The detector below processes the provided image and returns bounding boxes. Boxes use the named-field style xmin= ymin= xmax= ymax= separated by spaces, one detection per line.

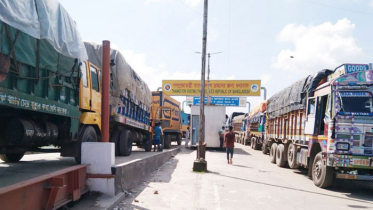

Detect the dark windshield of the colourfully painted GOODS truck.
xmin=339 ymin=92 xmax=373 ymax=113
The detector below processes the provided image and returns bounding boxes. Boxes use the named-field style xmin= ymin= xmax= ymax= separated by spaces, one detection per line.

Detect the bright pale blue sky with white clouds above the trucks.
xmin=59 ymin=0 xmax=373 ymax=114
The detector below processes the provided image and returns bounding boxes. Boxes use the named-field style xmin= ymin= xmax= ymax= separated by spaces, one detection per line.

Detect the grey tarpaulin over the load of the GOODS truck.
xmin=267 ymin=76 xmax=313 ymax=119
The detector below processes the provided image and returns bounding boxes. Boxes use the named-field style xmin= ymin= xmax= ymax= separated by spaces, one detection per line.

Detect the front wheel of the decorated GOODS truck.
xmin=312 ymin=152 xmax=334 ymax=188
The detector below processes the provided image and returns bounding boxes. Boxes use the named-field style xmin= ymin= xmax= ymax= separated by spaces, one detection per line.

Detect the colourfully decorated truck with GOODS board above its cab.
xmin=265 ymin=64 xmax=373 ymax=188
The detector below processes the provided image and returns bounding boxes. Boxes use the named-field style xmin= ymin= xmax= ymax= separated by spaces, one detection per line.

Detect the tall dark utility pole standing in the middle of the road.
xmin=193 ymin=0 xmax=208 ymax=172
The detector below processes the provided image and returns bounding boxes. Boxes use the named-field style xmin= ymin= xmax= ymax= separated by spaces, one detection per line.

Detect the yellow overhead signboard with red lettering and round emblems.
xmin=162 ymin=80 xmax=261 ymax=96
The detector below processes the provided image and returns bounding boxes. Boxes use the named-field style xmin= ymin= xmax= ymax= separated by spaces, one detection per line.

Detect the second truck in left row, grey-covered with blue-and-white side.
xmin=81 ymin=42 xmax=152 ymax=156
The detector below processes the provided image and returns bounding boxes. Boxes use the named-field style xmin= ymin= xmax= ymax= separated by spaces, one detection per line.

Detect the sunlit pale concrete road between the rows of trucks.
xmin=117 ymin=144 xmax=373 ymax=210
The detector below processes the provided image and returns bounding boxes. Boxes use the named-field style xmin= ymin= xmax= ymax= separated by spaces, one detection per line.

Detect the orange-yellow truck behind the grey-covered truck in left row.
xmin=152 ymin=91 xmax=182 ymax=149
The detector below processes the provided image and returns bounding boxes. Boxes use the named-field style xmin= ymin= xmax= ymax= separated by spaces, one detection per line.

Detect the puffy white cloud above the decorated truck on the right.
xmin=272 ymin=18 xmax=364 ymax=73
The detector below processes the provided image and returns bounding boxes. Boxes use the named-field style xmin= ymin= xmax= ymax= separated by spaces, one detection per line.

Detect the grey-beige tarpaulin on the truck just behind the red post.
xmin=84 ymin=42 xmax=151 ymax=108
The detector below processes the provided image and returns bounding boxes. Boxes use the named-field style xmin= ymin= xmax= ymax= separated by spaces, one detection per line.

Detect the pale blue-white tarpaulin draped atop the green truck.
xmin=0 ymin=0 xmax=88 ymax=61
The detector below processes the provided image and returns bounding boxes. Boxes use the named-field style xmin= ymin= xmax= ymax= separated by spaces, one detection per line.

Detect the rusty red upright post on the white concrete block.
xmin=101 ymin=40 xmax=110 ymax=142
